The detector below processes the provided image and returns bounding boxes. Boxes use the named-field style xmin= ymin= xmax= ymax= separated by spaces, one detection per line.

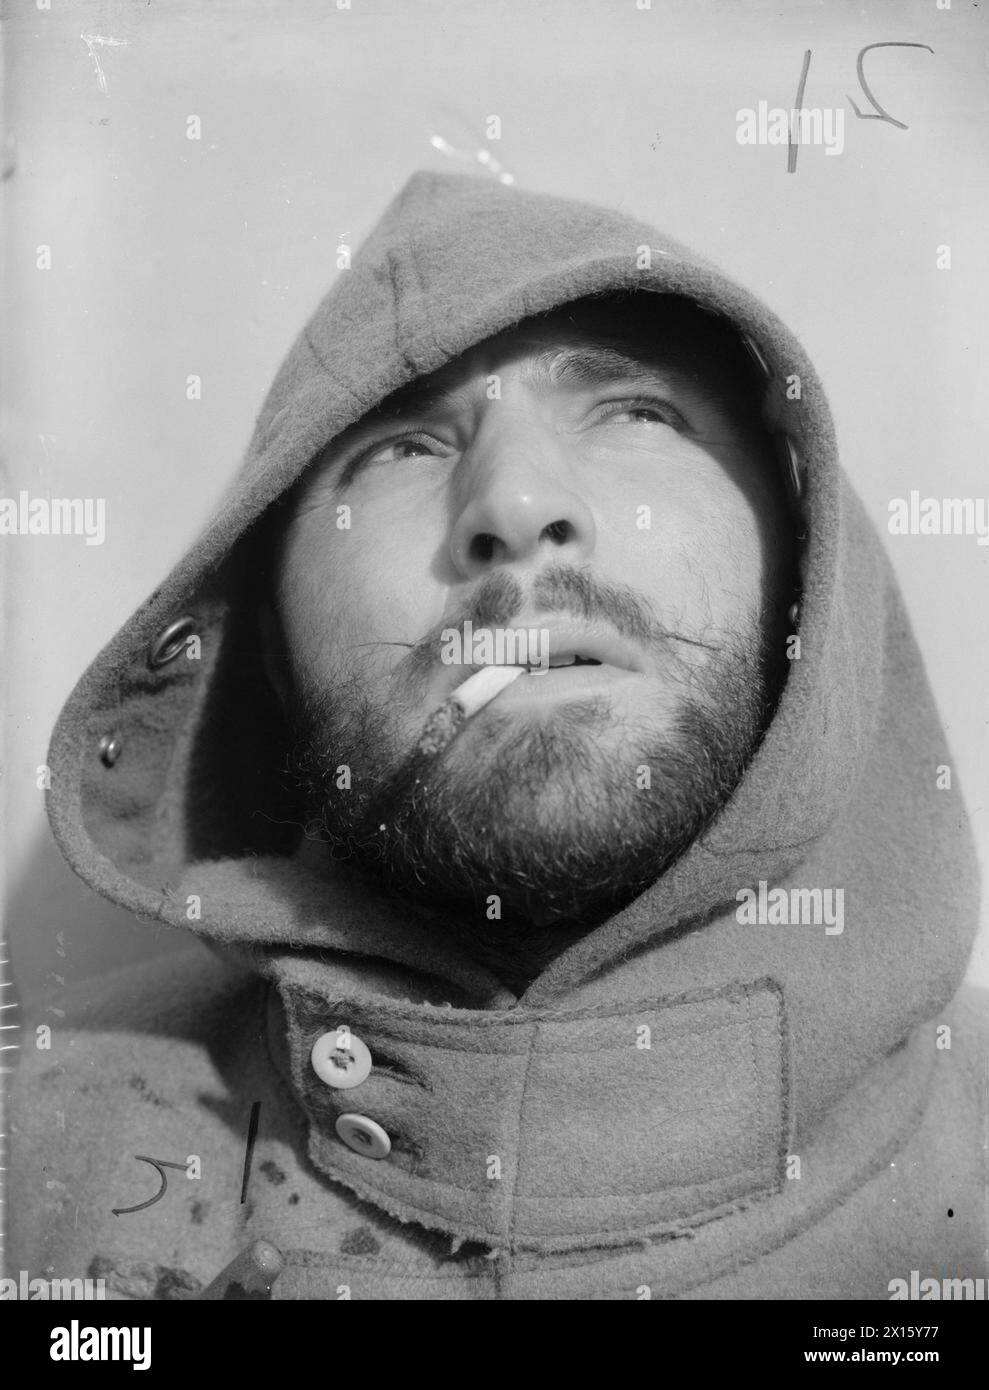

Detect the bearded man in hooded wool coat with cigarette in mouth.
xmin=14 ymin=174 xmax=986 ymax=1300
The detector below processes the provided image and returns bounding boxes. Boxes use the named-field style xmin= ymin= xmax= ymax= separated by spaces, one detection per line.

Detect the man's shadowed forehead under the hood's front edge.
xmin=372 ymin=293 xmax=758 ymax=416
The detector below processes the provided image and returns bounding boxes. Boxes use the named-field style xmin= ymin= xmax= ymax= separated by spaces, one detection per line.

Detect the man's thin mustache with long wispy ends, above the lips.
xmin=347 ymin=564 xmax=722 ymax=688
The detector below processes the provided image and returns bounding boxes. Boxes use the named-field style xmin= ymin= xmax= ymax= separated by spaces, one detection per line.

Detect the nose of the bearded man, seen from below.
xmin=450 ymin=431 xmax=597 ymax=578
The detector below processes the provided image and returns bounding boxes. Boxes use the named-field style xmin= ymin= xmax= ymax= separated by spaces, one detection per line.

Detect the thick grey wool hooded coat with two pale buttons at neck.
xmin=8 ymin=174 xmax=989 ymax=1300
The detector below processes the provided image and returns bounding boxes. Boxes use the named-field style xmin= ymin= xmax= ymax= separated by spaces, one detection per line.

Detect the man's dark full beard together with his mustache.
xmin=280 ymin=569 xmax=785 ymax=990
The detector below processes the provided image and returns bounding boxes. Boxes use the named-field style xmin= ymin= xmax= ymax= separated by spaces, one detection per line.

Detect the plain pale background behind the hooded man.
xmin=0 ymin=0 xmax=989 ymax=997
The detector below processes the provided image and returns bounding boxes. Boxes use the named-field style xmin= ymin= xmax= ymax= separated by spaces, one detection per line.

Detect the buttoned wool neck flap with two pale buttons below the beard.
xmin=268 ymin=954 xmax=789 ymax=1252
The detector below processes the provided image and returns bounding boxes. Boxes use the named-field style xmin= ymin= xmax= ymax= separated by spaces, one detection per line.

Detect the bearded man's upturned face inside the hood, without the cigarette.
xmin=268 ymin=296 xmax=790 ymax=978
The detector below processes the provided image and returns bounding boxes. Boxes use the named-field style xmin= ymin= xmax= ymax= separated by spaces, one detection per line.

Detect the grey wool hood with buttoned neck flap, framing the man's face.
xmin=40 ymin=174 xmax=978 ymax=1252
